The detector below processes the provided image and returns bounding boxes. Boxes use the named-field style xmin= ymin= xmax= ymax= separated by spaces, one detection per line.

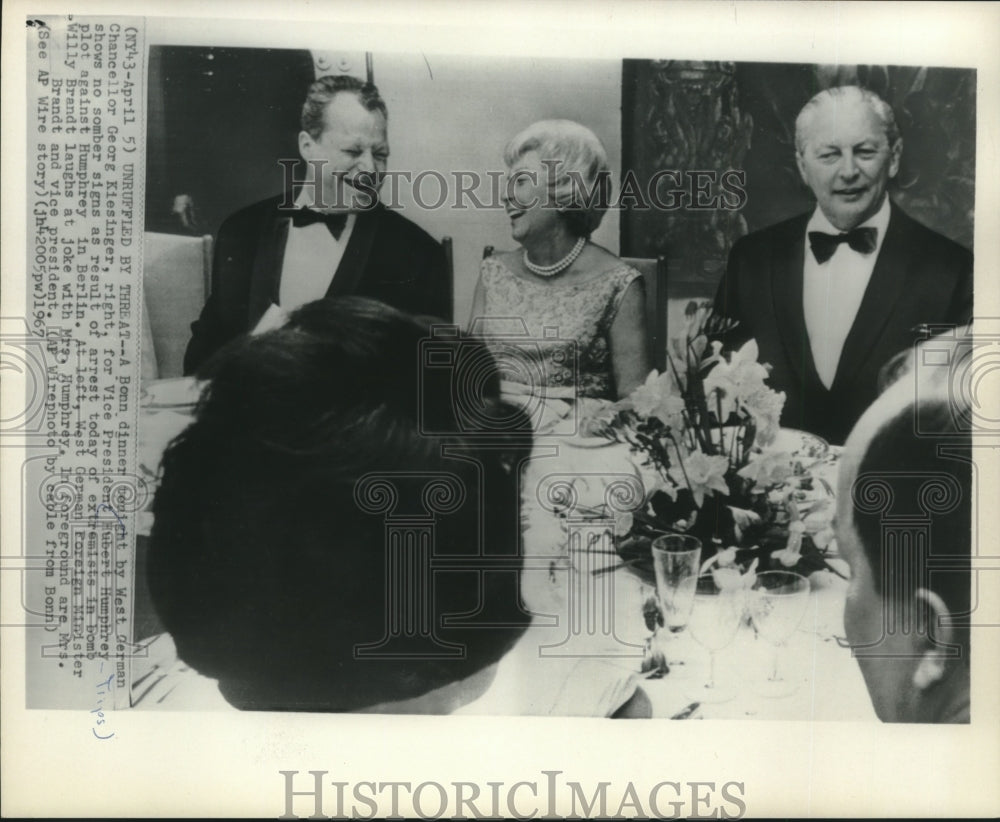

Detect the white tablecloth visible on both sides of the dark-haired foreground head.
xmin=137 ymin=382 xmax=874 ymax=720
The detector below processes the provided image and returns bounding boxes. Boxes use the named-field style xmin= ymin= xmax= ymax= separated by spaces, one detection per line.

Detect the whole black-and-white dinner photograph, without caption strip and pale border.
xmin=127 ymin=46 xmax=976 ymax=722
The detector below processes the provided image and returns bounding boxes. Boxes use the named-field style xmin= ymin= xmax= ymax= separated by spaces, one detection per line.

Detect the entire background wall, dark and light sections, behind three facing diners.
xmin=146 ymin=51 xmax=976 ymax=316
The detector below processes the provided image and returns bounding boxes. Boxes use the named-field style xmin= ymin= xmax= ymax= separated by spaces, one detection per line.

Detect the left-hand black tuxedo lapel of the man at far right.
xmin=770 ymin=215 xmax=818 ymax=384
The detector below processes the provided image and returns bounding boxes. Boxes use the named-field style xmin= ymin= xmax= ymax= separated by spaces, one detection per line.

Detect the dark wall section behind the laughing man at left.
xmin=146 ymin=46 xmax=315 ymax=240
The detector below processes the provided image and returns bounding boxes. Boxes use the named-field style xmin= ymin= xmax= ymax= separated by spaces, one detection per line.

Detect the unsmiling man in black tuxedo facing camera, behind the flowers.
xmin=715 ymin=86 xmax=973 ymax=444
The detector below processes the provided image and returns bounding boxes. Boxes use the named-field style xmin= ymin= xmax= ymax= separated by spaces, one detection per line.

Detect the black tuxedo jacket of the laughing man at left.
xmin=184 ymin=197 xmax=451 ymax=374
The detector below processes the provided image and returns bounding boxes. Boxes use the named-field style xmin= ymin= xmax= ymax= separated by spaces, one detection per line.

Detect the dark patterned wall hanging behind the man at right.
xmin=621 ymin=60 xmax=976 ymax=297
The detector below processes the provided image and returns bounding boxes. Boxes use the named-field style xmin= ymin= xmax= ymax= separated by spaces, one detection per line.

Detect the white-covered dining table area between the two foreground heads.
xmin=470 ymin=428 xmax=875 ymax=721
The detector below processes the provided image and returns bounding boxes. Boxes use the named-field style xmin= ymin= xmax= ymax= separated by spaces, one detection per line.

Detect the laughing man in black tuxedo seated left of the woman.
xmin=184 ymin=77 xmax=451 ymax=374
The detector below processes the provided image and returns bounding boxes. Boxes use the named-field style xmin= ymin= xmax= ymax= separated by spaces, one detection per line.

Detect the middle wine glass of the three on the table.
xmin=688 ymin=573 xmax=746 ymax=702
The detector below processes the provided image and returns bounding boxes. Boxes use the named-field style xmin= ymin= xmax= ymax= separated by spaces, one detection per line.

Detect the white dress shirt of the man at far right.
xmin=802 ymin=197 xmax=890 ymax=388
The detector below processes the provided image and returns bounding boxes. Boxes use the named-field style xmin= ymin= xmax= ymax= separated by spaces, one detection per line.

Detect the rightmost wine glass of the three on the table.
xmin=748 ymin=571 xmax=809 ymax=697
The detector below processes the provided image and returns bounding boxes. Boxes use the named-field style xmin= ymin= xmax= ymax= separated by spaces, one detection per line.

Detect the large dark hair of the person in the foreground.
xmin=149 ymin=298 xmax=531 ymax=711
